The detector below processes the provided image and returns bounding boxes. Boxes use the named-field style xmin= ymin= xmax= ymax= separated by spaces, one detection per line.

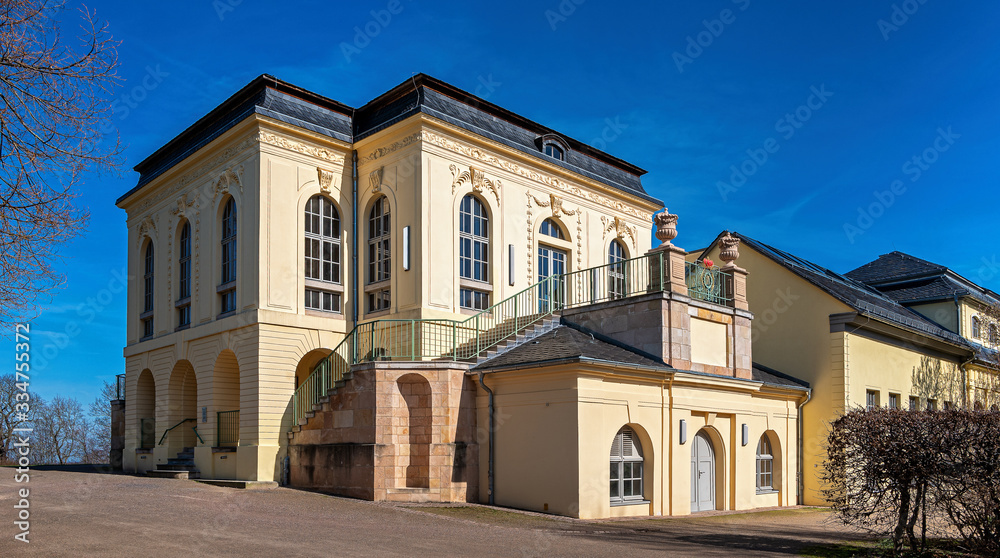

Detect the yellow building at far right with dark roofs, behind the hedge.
xmin=689 ymin=233 xmax=997 ymax=505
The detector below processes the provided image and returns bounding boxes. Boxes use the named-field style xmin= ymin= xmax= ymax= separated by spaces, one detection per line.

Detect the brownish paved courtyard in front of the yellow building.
xmin=0 ymin=469 xmax=872 ymax=558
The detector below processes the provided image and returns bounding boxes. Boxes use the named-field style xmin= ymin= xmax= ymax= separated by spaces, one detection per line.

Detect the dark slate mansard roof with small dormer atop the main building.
xmin=116 ymin=74 xmax=662 ymax=204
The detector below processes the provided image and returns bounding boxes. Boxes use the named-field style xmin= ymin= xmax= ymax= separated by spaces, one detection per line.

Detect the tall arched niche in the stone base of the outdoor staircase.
xmin=393 ymin=373 xmax=433 ymax=488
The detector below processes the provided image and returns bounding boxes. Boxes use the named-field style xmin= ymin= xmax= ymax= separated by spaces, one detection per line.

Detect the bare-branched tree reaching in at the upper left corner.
xmin=0 ymin=0 xmax=121 ymax=325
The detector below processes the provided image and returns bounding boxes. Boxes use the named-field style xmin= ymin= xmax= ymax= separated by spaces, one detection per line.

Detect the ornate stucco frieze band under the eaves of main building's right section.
xmin=358 ymin=130 xmax=653 ymax=221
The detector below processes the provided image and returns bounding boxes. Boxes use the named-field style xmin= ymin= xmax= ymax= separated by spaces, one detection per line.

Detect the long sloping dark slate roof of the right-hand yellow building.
xmin=733 ymin=233 xmax=971 ymax=348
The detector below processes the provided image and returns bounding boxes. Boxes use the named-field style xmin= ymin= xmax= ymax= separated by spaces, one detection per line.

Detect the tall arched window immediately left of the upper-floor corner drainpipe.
xmin=305 ymin=195 xmax=341 ymax=312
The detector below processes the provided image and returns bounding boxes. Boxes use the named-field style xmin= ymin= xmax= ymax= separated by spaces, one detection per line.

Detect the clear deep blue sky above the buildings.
xmin=7 ymin=0 xmax=1000 ymax=410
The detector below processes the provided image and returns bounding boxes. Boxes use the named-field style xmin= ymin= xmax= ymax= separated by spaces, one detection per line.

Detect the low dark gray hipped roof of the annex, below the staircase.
xmin=475 ymin=325 xmax=671 ymax=370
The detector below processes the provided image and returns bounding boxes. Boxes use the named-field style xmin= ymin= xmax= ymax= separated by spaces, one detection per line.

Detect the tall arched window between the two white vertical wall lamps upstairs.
xmin=458 ymin=194 xmax=490 ymax=310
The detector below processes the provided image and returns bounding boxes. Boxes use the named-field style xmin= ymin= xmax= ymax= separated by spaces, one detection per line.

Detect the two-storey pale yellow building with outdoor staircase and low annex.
xmin=117 ymin=75 xmax=809 ymax=517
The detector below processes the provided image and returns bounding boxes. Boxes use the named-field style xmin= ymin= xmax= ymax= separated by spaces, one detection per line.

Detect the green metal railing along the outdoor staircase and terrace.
xmin=292 ymin=251 xmax=731 ymax=424
